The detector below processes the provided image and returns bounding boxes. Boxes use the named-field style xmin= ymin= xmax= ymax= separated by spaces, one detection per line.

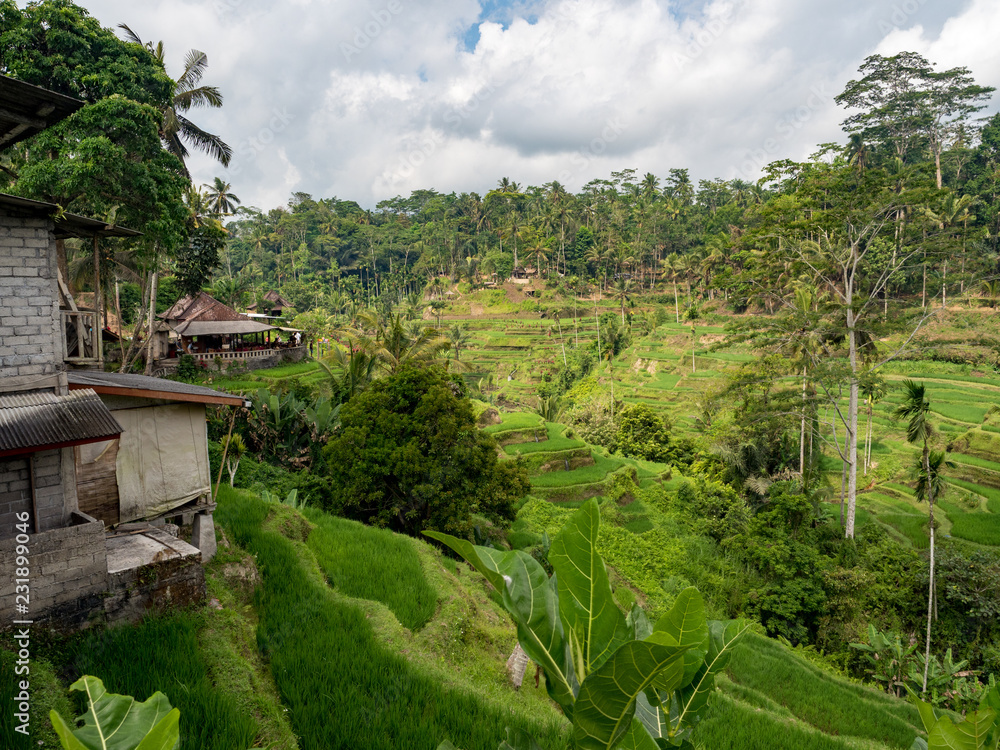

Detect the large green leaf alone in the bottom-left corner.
xmin=49 ymin=675 xmax=181 ymax=750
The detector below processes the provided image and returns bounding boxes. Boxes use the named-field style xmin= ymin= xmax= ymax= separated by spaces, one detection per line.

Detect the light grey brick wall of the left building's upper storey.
xmin=0 ymin=208 xmax=63 ymax=385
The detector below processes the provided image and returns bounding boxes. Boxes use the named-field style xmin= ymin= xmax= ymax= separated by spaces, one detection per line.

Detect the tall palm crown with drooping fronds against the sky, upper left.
xmin=118 ymin=23 xmax=233 ymax=176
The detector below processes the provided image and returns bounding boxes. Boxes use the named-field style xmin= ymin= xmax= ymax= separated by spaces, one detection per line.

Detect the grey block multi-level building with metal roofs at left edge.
xmin=0 ymin=76 xmax=230 ymax=627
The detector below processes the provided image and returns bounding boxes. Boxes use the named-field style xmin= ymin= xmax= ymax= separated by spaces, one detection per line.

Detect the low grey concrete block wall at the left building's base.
xmin=0 ymin=521 xmax=107 ymax=626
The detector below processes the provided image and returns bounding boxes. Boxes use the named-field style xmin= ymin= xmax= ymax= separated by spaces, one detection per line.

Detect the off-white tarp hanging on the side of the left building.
xmin=113 ymin=403 xmax=211 ymax=523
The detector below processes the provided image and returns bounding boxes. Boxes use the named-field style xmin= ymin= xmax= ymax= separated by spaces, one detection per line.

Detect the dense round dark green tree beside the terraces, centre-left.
xmin=324 ymin=367 xmax=530 ymax=538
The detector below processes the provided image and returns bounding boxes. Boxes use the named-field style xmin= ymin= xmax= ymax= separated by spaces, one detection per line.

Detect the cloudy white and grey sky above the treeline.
xmin=66 ymin=0 xmax=1000 ymax=209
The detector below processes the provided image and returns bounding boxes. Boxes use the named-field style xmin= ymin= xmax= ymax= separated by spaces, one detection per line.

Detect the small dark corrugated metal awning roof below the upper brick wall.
xmin=0 ymin=388 xmax=122 ymax=456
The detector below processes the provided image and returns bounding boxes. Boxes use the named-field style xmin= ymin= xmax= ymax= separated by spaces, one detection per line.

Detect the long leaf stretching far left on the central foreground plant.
xmin=424 ymin=531 xmax=575 ymax=718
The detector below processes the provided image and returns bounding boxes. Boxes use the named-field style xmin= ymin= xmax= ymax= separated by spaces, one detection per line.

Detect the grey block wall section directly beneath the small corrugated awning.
xmin=0 ymin=450 xmax=76 ymax=539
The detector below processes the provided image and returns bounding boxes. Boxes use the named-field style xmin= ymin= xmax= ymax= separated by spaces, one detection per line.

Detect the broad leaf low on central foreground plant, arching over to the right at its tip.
xmin=573 ymin=641 xmax=687 ymax=750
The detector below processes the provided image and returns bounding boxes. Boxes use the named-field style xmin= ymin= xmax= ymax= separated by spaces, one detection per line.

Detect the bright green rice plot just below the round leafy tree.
xmin=298 ymin=510 xmax=437 ymax=630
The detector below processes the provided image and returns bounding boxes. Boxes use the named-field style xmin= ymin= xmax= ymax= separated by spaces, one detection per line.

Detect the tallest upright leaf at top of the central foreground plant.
xmin=549 ymin=498 xmax=629 ymax=679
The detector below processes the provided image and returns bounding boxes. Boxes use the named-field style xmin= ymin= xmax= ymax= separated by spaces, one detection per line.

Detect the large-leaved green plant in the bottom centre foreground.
xmin=424 ymin=499 xmax=747 ymax=750
